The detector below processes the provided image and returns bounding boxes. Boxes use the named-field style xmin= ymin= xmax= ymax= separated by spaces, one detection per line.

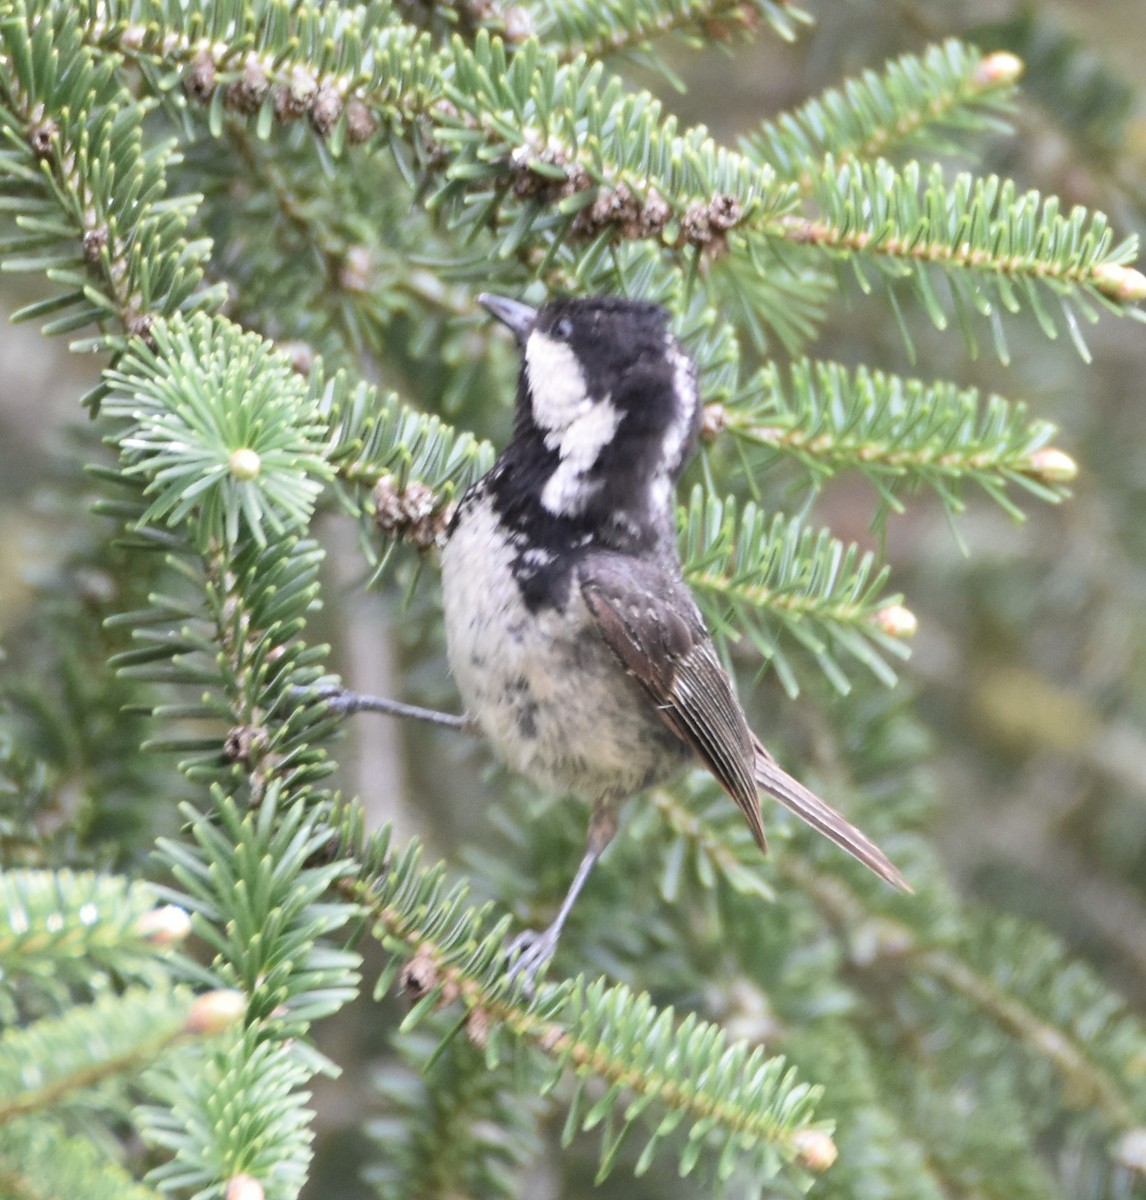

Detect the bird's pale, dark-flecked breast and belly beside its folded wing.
xmin=442 ymin=508 xmax=690 ymax=800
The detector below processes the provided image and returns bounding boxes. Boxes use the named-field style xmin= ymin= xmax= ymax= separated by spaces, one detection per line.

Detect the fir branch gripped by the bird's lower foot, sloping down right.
xmin=342 ymin=817 xmax=835 ymax=1178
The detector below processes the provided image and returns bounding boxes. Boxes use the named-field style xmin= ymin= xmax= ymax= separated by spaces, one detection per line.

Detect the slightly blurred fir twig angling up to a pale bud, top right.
xmin=742 ymin=38 xmax=1022 ymax=183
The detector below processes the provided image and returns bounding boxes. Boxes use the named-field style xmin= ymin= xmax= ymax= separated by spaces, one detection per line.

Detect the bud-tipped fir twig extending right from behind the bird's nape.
xmin=707 ymin=359 xmax=1075 ymax=518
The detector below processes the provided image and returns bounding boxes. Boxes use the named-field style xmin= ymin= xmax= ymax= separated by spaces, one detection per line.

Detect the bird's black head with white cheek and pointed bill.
xmin=481 ymin=296 xmax=700 ymax=532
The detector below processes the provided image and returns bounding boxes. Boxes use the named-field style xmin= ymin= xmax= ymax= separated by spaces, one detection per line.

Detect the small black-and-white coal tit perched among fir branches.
xmin=442 ymin=295 xmax=907 ymax=980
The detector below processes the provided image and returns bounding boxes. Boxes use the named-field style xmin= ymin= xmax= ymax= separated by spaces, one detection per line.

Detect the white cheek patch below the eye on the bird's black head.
xmin=526 ymin=332 xmax=620 ymax=516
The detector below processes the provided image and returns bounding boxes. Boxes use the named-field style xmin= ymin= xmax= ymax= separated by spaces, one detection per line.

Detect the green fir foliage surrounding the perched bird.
xmin=0 ymin=0 xmax=1146 ymax=1200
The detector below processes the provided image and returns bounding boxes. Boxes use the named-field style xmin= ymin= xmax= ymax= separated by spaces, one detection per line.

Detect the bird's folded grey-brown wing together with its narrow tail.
xmin=578 ymin=553 xmax=911 ymax=892
